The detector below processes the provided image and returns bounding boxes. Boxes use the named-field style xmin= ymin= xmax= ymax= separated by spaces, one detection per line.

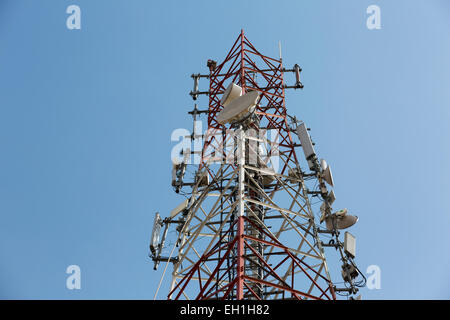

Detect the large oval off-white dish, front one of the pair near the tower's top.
xmin=217 ymin=91 xmax=260 ymax=124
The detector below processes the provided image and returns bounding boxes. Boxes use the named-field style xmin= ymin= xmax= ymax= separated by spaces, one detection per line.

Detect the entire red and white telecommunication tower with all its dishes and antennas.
xmin=150 ymin=31 xmax=365 ymax=300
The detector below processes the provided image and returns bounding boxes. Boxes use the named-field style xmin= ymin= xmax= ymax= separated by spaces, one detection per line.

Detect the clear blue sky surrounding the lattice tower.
xmin=0 ymin=0 xmax=450 ymax=299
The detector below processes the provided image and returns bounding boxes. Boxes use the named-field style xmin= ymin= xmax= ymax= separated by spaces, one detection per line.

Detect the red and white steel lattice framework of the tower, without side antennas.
xmin=158 ymin=31 xmax=336 ymax=299
